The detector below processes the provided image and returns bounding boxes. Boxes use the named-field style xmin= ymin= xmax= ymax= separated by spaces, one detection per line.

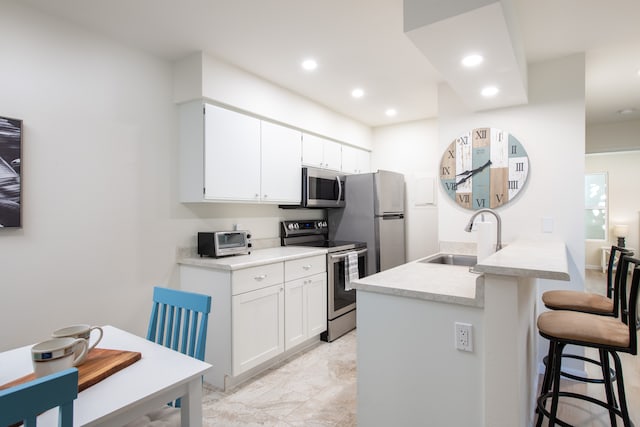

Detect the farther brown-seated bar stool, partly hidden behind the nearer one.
xmin=542 ymin=245 xmax=633 ymax=384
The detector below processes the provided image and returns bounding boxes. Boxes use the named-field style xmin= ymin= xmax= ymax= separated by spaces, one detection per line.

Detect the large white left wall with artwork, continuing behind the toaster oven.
xmin=0 ymin=0 xmax=323 ymax=351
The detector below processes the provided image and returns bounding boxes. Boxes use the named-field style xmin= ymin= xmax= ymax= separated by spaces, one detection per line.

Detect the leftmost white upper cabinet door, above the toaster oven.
xmin=204 ymin=104 xmax=260 ymax=201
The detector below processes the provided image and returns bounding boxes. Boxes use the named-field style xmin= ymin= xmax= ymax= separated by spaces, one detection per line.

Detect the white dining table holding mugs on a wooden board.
xmin=0 ymin=326 xmax=211 ymax=427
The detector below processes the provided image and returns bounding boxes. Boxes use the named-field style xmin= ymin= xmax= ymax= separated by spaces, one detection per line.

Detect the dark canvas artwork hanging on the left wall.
xmin=0 ymin=117 xmax=22 ymax=228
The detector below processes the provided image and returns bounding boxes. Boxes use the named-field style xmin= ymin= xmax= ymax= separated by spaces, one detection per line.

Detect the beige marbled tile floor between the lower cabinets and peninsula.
xmin=203 ymin=331 xmax=356 ymax=427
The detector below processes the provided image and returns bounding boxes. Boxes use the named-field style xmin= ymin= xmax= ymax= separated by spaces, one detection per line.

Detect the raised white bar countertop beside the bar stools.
xmin=475 ymin=240 xmax=570 ymax=281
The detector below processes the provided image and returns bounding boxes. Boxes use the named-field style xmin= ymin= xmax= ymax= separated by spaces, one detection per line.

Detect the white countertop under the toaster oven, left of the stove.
xmin=178 ymin=246 xmax=327 ymax=271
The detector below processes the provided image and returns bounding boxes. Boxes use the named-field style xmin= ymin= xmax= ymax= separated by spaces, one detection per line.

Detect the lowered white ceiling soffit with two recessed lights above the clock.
xmin=404 ymin=0 xmax=527 ymax=111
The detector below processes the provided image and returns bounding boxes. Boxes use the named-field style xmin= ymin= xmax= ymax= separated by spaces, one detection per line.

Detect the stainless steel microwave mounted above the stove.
xmin=302 ymin=167 xmax=346 ymax=208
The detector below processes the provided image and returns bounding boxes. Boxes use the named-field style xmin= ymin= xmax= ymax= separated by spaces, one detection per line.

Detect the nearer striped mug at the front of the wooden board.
xmin=31 ymin=337 xmax=88 ymax=378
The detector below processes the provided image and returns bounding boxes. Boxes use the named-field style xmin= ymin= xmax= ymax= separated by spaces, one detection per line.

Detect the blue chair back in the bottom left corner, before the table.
xmin=0 ymin=368 xmax=78 ymax=427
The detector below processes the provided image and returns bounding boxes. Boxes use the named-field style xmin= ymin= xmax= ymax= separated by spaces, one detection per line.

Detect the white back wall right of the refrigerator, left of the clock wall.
xmin=371 ymin=119 xmax=440 ymax=261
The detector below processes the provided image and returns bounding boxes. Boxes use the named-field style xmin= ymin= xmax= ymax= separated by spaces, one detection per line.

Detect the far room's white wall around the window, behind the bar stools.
xmin=585 ymin=151 xmax=640 ymax=268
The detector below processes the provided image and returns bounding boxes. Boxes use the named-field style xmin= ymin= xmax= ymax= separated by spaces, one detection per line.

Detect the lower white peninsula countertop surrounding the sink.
xmin=352 ymin=254 xmax=484 ymax=307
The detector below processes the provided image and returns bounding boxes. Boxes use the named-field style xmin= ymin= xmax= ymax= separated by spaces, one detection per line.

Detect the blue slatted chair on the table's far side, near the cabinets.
xmin=147 ymin=286 xmax=211 ymax=360
